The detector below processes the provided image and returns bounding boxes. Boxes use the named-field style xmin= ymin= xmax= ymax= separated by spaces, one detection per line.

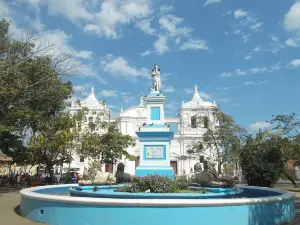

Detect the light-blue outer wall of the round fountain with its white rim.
xmin=20 ymin=185 xmax=295 ymax=225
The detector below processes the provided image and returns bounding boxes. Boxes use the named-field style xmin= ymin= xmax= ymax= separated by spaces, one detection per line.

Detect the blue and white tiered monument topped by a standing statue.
xmin=135 ymin=65 xmax=174 ymax=179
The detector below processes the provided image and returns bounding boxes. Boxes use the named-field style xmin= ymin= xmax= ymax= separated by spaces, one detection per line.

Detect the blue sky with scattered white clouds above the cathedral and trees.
xmin=0 ymin=0 xmax=300 ymax=130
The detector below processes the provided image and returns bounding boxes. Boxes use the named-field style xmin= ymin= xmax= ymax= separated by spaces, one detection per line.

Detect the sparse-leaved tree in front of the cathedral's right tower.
xmin=192 ymin=108 xmax=245 ymax=174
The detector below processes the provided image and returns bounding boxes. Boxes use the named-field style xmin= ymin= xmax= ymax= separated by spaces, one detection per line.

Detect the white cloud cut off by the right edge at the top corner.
xmin=284 ymin=1 xmax=300 ymax=32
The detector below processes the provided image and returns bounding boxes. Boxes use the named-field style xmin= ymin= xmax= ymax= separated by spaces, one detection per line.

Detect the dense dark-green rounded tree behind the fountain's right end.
xmin=239 ymin=132 xmax=289 ymax=187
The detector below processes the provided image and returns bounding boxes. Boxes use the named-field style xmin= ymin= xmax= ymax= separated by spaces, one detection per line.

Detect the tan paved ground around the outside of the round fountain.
xmin=0 ymin=186 xmax=300 ymax=225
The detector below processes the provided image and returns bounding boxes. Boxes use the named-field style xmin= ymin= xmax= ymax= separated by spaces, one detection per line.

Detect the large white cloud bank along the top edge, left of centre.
xmin=18 ymin=0 xmax=152 ymax=39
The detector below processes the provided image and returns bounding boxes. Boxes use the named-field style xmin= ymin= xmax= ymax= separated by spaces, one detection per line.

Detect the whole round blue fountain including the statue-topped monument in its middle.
xmin=20 ymin=66 xmax=295 ymax=225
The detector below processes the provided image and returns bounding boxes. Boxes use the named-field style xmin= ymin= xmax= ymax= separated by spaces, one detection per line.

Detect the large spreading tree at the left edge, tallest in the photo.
xmin=0 ymin=20 xmax=72 ymax=157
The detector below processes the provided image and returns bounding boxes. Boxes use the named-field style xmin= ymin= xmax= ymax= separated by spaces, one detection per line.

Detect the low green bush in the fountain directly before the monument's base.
xmin=117 ymin=175 xmax=178 ymax=193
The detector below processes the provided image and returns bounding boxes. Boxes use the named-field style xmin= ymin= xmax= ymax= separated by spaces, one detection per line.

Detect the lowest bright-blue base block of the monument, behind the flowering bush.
xmin=135 ymin=166 xmax=175 ymax=180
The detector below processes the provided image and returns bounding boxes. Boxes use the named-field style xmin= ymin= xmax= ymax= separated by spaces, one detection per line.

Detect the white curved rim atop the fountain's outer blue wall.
xmin=20 ymin=184 xmax=295 ymax=207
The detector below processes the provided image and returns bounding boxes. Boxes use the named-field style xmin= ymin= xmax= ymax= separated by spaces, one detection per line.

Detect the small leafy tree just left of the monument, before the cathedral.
xmin=78 ymin=121 xmax=135 ymax=170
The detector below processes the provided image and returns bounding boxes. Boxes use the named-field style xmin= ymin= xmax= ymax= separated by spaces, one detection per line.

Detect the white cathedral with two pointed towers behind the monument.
xmin=69 ymin=66 xmax=218 ymax=175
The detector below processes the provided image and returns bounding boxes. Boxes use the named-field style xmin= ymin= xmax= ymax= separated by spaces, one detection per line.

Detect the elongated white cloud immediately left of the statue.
xmin=100 ymin=54 xmax=150 ymax=79
